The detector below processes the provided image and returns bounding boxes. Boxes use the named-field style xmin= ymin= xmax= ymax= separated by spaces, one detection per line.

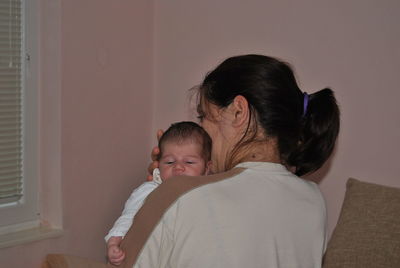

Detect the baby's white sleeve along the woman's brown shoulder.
xmin=104 ymin=181 xmax=159 ymax=242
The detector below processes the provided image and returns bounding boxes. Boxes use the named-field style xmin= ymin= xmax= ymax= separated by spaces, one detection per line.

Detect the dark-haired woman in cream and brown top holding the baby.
xmin=119 ymin=55 xmax=339 ymax=268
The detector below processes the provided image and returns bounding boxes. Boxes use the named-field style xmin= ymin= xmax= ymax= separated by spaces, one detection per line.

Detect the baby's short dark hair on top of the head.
xmin=158 ymin=121 xmax=212 ymax=161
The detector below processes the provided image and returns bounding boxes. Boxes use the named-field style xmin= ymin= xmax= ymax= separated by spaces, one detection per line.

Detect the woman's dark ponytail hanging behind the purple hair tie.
xmin=286 ymin=88 xmax=340 ymax=176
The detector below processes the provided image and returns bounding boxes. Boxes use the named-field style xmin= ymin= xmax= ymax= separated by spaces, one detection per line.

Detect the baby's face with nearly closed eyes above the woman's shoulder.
xmin=159 ymin=141 xmax=210 ymax=180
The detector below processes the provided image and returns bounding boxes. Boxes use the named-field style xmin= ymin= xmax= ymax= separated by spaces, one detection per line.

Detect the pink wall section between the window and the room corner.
xmin=0 ymin=0 xmax=154 ymax=267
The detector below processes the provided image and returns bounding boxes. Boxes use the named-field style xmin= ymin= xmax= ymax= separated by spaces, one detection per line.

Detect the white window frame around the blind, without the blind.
xmin=0 ymin=0 xmax=40 ymax=231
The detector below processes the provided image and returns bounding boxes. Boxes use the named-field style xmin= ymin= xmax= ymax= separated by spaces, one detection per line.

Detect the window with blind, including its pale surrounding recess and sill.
xmin=0 ymin=0 xmax=63 ymax=248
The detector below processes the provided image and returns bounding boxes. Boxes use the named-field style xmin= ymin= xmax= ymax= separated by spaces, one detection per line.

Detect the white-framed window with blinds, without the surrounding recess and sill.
xmin=0 ymin=0 xmax=39 ymax=234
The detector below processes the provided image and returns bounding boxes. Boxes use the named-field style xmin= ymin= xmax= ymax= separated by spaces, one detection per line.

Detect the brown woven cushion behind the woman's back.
xmin=322 ymin=178 xmax=400 ymax=268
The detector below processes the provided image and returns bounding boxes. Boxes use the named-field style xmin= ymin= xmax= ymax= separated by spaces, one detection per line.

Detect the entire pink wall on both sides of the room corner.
xmin=0 ymin=0 xmax=400 ymax=267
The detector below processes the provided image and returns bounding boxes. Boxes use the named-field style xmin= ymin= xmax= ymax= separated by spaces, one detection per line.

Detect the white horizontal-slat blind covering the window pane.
xmin=0 ymin=0 xmax=23 ymax=205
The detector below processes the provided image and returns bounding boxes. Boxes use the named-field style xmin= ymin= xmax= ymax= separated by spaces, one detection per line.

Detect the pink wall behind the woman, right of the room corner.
xmin=153 ymin=0 xmax=400 ymax=234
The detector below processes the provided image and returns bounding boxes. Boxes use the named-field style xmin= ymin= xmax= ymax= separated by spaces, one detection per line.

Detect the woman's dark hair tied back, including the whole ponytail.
xmin=199 ymin=55 xmax=340 ymax=176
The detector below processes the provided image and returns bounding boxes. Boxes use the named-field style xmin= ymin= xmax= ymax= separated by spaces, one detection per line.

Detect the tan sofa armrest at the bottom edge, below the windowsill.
xmin=42 ymin=254 xmax=108 ymax=268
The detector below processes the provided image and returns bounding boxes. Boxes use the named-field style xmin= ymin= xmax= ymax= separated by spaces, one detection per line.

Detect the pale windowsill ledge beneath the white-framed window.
xmin=0 ymin=227 xmax=64 ymax=248
